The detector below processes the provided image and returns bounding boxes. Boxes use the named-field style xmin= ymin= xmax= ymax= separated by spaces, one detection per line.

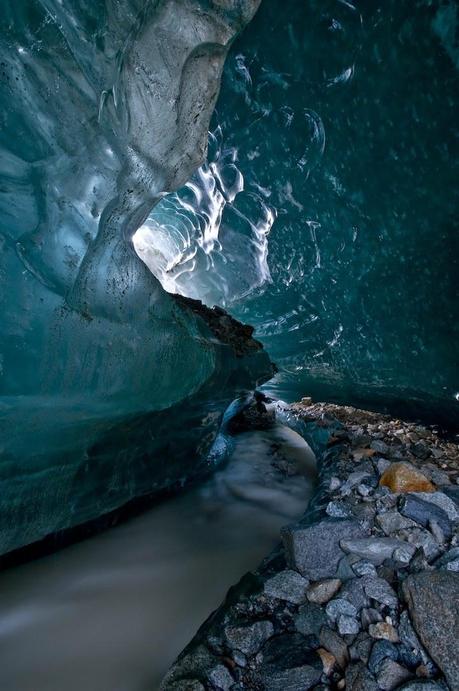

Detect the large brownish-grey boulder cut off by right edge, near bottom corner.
xmin=403 ymin=571 xmax=459 ymax=691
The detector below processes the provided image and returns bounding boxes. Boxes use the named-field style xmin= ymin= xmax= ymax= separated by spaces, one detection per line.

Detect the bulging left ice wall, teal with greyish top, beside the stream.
xmin=0 ymin=0 xmax=270 ymax=551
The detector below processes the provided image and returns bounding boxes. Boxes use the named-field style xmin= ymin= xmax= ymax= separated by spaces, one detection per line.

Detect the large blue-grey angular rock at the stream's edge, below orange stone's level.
xmin=282 ymin=518 xmax=368 ymax=581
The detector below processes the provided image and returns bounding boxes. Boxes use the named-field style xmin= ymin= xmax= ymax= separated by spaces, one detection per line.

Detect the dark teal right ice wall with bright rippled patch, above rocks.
xmin=137 ymin=0 xmax=459 ymax=424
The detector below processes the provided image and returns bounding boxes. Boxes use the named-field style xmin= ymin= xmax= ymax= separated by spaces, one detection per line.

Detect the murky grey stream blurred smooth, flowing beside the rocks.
xmin=0 ymin=425 xmax=315 ymax=691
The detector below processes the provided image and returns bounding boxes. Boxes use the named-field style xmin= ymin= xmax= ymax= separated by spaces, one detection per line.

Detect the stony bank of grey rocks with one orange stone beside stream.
xmin=161 ymin=399 xmax=459 ymax=691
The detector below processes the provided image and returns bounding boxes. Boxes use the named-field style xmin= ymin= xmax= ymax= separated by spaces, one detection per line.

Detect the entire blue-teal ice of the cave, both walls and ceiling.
xmin=0 ymin=0 xmax=459 ymax=551
